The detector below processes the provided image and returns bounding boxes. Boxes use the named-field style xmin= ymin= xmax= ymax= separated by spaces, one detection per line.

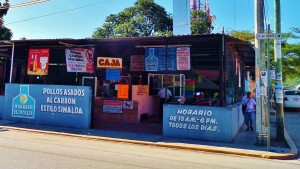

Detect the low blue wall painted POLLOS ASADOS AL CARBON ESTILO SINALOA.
xmin=2 ymin=84 xmax=92 ymax=129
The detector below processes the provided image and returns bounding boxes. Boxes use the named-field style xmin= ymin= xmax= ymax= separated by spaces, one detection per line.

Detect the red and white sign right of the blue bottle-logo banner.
xmin=176 ymin=47 xmax=191 ymax=70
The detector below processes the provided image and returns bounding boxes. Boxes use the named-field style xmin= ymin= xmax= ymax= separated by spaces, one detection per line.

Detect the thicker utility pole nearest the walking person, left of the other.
xmin=254 ymin=0 xmax=268 ymax=146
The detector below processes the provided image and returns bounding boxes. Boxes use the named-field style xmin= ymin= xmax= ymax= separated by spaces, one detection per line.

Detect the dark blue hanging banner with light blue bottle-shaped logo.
xmin=145 ymin=47 xmax=176 ymax=71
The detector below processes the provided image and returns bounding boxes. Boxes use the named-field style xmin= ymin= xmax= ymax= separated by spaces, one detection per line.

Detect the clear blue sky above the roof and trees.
xmin=0 ymin=0 xmax=300 ymax=40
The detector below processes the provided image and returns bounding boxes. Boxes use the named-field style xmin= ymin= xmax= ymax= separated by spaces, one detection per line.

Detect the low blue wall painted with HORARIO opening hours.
xmin=163 ymin=104 xmax=241 ymax=142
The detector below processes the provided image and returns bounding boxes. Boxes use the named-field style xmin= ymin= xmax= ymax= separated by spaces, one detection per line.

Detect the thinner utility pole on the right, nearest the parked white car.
xmin=274 ymin=0 xmax=284 ymax=140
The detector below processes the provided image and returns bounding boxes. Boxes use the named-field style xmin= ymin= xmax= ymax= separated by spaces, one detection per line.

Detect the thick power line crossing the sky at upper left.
xmin=5 ymin=0 xmax=114 ymax=25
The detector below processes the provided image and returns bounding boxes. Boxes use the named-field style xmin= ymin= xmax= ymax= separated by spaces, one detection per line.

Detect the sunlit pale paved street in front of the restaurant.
xmin=0 ymin=130 xmax=300 ymax=169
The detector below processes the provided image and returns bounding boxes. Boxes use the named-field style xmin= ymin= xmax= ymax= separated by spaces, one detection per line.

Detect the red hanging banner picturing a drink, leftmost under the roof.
xmin=27 ymin=49 xmax=50 ymax=76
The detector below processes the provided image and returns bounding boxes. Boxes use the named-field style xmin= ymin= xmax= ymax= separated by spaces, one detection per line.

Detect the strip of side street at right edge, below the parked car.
xmin=284 ymin=110 xmax=300 ymax=160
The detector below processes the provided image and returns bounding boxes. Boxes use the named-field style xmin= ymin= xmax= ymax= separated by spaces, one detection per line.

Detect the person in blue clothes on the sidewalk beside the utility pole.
xmin=242 ymin=92 xmax=256 ymax=131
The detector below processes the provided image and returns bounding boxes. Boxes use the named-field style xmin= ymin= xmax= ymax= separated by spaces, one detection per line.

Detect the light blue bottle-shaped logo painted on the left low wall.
xmin=12 ymin=85 xmax=35 ymax=119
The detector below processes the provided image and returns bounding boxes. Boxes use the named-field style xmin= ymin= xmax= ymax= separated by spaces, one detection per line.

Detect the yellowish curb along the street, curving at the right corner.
xmin=0 ymin=126 xmax=298 ymax=160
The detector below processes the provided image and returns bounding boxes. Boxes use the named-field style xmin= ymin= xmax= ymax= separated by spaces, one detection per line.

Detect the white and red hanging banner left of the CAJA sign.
xmin=65 ymin=48 xmax=94 ymax=73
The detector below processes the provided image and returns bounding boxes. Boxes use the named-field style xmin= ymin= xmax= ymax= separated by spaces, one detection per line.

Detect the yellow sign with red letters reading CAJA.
xmin=97 ymin=57 xmax=122 ymax=69
